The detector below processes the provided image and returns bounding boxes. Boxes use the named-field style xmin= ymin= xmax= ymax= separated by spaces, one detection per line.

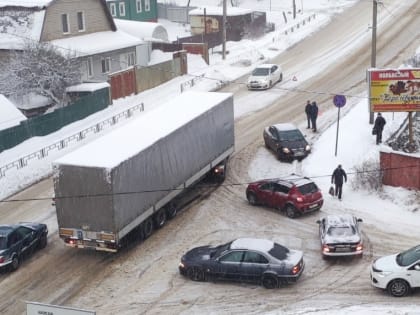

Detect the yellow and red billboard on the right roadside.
xmin=367 ymin=68 xmax=420 ymax=112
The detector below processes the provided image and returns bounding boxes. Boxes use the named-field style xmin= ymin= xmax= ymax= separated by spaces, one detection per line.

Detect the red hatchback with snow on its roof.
xmin=246 ymin=174 xmax=324 ymax=218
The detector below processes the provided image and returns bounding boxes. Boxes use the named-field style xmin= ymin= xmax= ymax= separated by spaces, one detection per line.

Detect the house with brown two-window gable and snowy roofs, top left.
xmin=0 ymin=0 xmax=144 ymax=82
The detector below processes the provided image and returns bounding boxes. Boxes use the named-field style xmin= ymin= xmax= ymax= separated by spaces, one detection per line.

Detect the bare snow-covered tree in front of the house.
xmin=0 ymin=42 xmax=82 ymax=107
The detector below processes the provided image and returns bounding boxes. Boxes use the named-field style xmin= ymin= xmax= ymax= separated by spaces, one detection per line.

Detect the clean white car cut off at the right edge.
xmin=370 ymin=245 xmax=420 ymax=297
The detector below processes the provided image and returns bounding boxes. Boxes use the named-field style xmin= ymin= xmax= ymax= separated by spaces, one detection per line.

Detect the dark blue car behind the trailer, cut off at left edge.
xmin=0 ymin=222 xmax=48 ymax=271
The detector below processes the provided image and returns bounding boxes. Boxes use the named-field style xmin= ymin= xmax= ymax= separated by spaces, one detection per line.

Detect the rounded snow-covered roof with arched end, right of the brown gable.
xmin=114 ymin=19 xmax=169 ymax=42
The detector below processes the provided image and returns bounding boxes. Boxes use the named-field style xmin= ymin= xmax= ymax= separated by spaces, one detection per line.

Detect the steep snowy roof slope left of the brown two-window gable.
xmin=0 ymin=10 xmax=45 ymax=50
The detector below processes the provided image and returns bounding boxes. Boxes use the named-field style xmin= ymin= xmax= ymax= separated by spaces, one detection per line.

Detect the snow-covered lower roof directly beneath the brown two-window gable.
xmin=50 ymin=30 xmax=143 ymax=57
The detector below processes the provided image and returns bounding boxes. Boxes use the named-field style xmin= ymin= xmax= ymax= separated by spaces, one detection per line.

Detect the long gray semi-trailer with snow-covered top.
xmin=53 ymin=92 xmax=234 ymax=252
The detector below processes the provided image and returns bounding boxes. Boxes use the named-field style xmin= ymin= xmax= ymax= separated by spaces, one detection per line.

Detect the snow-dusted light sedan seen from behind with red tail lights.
xmin=317 ymin=214 xmax=363 ymax=258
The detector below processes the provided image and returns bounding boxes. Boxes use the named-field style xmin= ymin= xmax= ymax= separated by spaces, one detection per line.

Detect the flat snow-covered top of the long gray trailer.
xmin=55 ymin=91 xmax=231 ymax=169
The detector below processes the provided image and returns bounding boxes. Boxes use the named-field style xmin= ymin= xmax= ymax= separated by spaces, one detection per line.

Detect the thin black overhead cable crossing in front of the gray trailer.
xmin=0 ymin=165 xmax=417 ymax=203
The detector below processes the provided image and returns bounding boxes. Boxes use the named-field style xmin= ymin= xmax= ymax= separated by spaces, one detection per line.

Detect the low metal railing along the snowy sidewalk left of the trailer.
xmin=0 ymin=103 xmax=144 ymax=180
